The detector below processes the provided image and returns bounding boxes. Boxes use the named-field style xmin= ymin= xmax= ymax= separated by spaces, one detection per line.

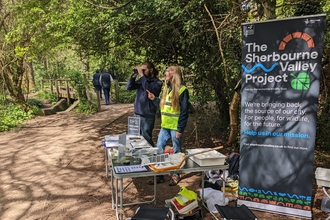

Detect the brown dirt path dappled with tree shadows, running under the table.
xmin=0 ymin=104 xmax=324 ymax=220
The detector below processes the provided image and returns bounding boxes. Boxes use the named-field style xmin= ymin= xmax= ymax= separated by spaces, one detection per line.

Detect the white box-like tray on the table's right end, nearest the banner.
xmin=187 ymin=148 xmax=226 ymax=166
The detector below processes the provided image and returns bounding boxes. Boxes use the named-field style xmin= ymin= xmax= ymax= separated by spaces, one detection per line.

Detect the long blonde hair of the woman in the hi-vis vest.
xmin=160 ymin=65 xmax=182 ymax=111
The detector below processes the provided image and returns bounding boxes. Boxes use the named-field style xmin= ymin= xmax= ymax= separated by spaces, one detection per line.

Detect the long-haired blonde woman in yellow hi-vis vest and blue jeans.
xmin=147 ymin=65 xmax=189 ymax=186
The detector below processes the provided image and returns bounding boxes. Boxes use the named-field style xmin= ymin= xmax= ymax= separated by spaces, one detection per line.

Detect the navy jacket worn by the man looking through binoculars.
xmin=126 ymin=76 xmax=163 ymax=117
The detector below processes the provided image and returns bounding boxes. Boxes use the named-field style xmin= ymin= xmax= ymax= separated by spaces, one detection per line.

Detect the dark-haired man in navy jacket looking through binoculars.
xmin=126 ymin=61 xmax=163 ymax=147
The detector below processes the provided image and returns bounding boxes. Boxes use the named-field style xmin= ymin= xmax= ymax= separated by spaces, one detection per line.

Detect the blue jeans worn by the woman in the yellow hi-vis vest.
xmin=157 ymin=128 xmax=182 ymax=154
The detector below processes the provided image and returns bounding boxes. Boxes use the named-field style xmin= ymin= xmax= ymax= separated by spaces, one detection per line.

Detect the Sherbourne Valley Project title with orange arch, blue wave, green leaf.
xmin=242 ymin=31 xmax=320 ymax=90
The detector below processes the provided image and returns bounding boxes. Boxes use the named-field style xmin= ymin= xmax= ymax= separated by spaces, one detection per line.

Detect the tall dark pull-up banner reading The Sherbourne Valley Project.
xmin=237 ymin=15 xmax=325 ymax=218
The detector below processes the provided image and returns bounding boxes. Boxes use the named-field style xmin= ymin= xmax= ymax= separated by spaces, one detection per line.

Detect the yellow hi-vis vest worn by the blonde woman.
xmin=160 ymin=86 xmax=187 ymax=131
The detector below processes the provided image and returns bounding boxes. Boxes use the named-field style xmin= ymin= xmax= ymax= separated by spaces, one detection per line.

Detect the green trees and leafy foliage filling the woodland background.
xmin=0 ymin=0 xmax=330 ymax=148
